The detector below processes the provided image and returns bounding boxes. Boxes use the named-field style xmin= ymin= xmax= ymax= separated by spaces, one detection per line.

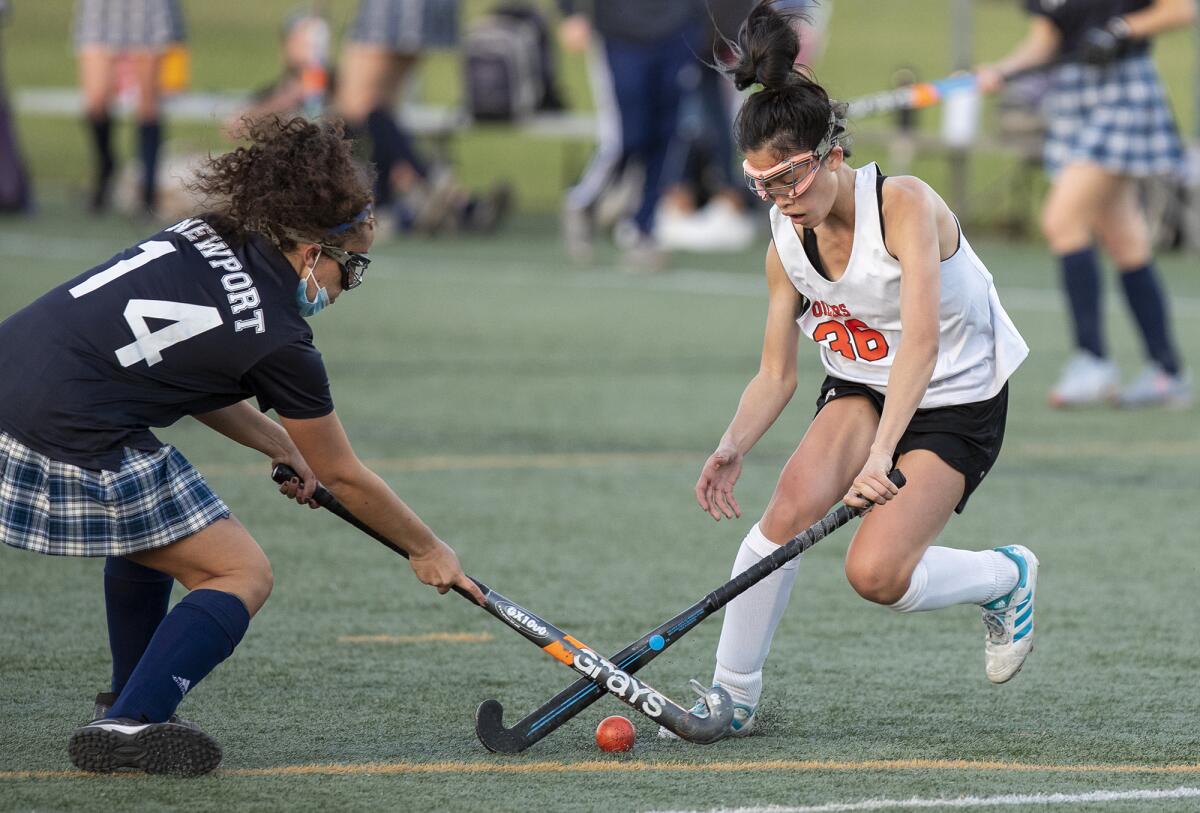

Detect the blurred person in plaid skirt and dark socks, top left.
xmin=74 ymin=0 xmax=184 ymax=213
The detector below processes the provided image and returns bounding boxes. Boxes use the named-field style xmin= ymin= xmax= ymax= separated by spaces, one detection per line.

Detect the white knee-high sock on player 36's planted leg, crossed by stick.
xmin=713 ymin=525 xmax=800 ymax=706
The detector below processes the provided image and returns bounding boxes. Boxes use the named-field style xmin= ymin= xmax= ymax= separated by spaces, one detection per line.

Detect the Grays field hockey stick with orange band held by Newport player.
xmin=271 ymin=463 xmax=733 ymax=745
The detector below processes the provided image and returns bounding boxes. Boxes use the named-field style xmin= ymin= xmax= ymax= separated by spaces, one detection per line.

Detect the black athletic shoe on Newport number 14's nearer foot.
xmin=67 ymin=718 xmax=221 ymax=776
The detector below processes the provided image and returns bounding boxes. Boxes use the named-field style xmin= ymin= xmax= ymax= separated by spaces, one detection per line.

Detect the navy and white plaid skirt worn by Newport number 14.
xmin=0 ymin=432 xmax=229 ymax=556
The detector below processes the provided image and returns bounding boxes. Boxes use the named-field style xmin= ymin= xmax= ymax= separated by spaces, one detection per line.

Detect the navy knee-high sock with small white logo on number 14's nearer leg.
xmin=108 ymin=590 xmax=250 ymax=723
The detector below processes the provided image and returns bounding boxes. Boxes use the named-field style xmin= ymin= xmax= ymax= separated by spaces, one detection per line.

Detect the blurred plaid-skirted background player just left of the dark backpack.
xmin=334 ymin=0 xmax=511 ymax=233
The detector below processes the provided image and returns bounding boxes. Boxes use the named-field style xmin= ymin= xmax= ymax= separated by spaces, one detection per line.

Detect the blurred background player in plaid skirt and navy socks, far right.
xmin=978 ymin=0 xmax=1196 ymax=407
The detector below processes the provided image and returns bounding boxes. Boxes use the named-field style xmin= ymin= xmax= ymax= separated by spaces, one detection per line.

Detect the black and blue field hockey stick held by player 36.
xmin=475 ymin=469 xmax=906 ymax=754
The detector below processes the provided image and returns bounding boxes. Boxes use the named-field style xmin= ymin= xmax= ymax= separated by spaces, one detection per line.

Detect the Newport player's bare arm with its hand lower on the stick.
xmin=282 ymin=412 xmax=484 ymax=604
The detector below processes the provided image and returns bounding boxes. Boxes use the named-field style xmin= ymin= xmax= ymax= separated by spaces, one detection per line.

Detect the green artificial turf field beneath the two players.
xmin=0 ymin=201 xmax=1200 ymax=813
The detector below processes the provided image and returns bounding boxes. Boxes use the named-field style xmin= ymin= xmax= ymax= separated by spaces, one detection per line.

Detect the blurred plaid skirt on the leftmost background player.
xmin=74 ymin=0 xmax=184 ymax=49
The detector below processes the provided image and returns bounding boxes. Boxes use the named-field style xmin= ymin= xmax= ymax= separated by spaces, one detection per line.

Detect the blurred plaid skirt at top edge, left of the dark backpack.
xmin=349 ymin=0 xmax=458 ymax=54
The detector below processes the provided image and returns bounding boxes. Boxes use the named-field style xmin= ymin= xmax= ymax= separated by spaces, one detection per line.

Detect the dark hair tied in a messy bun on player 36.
xmin=725 ymin=0 xmax=846 ymax=156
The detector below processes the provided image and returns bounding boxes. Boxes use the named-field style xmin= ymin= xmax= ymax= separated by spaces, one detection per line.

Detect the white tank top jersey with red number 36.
xmin=770 ymin=163 xmax=1030 ymax=409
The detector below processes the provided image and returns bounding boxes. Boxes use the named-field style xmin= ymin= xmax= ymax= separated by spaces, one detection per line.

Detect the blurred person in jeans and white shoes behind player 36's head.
xmin=655 ymin=0 xmax=832 ymax=252
